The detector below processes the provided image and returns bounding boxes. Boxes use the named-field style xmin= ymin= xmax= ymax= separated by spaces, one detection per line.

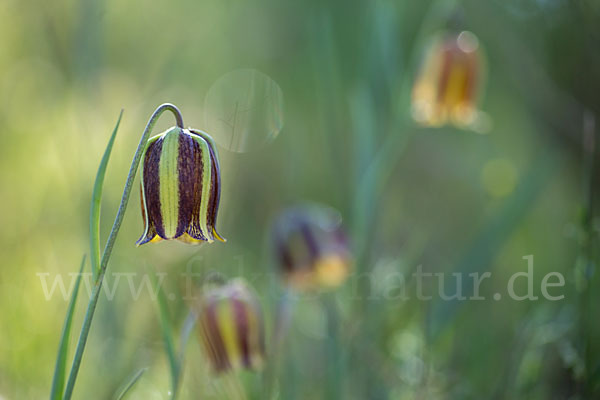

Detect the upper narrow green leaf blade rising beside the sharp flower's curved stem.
xmin=90 ymin=110 xmax=123 ymax=278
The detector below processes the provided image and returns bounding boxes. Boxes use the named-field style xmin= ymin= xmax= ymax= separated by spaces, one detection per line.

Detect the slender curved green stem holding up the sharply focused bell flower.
xmin=63 ymin=103 xmax=183 ymax=400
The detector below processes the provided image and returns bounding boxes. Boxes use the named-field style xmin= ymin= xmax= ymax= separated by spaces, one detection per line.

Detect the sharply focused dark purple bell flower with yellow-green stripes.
xmin=137 ymin=127 xmax=225 ymax=246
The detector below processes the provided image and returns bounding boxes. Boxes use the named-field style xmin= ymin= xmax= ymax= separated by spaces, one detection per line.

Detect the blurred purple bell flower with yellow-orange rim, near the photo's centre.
xmin=273 ymin=205 xmax=352 ymax=290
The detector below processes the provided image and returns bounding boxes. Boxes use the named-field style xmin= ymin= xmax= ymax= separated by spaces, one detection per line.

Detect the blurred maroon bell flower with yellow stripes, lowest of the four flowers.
xmin=198 ymin=279 xmax=265 ymax=373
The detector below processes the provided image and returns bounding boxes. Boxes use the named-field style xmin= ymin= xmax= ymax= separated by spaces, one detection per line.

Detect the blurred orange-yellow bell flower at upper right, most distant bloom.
xmin=412 ymin=31 xmax=484 ymax=127
